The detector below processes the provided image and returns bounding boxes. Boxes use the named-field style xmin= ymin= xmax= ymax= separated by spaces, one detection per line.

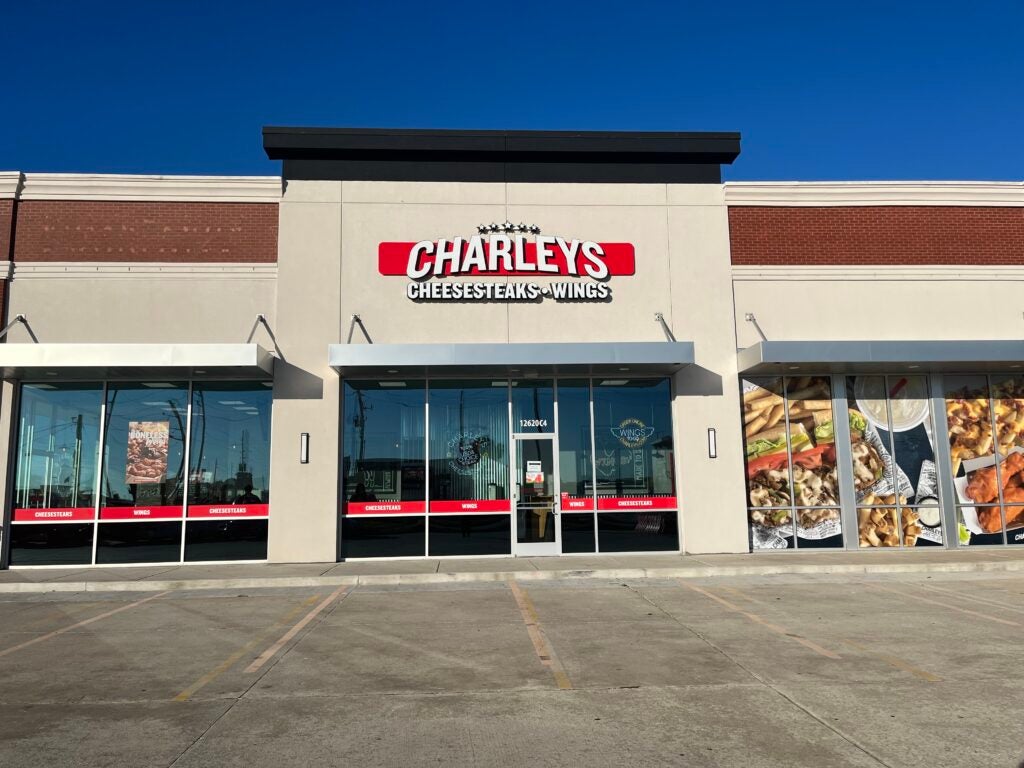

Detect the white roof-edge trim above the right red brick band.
xmin=725 ymin=181 xmax=1024 ymax=207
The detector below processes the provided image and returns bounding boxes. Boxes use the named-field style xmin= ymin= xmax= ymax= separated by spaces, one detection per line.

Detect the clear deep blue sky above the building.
xmin=0 ymin=0 xmax=1024 ymax=180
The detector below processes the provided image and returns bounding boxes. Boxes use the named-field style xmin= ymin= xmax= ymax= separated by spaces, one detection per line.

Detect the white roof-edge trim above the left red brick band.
xmin=19 ymin=173 xmax=282 ymax=203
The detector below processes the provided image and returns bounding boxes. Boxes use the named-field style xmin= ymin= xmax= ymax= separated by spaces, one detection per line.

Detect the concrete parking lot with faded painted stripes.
xmin=0 ymin=573 xmax=1024 ymax=768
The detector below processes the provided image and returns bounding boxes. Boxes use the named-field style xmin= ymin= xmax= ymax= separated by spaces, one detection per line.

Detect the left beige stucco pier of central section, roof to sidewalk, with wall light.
xmin=268 ymin=181 xmax=342 ymax=562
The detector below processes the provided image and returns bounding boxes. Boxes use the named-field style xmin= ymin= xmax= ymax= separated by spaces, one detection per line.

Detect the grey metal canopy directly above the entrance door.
xmin=328 ymin=341 xmax=693 ymax=379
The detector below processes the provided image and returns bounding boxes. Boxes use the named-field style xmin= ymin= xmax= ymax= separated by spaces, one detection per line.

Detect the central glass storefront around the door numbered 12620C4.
xmin=340 ymin=379 xmax=679 ymax=558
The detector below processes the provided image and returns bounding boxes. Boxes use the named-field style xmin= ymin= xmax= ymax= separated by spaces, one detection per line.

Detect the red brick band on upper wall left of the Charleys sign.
xmin=14 ymin=200 xmax=278 ymax=263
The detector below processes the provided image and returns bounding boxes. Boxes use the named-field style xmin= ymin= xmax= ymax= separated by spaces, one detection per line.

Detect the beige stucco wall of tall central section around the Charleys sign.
xmin=269 ymin=181 xmax=748 ymax=561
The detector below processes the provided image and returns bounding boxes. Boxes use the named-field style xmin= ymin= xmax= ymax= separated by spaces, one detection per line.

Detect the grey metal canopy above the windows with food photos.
xmin=737 ymin=340 xmax=1024 ymax=377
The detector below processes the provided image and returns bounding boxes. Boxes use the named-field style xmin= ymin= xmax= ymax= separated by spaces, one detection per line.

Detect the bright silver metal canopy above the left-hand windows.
xmin=0 ymin=343 xmax=274 ymax=381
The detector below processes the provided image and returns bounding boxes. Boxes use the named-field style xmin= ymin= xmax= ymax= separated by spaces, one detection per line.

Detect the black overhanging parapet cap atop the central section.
xmin=263 ymin=126 xmax=739 ymax=183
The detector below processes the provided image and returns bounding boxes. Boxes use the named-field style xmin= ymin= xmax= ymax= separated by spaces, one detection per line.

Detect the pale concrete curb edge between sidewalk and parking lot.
xmin=0 ymin=560 xmax=1024 ymax=594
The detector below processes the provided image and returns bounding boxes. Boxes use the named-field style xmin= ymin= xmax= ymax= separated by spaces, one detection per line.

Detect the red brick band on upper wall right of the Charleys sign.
xmin=729 ymin=206 xmax=1024 ymax=265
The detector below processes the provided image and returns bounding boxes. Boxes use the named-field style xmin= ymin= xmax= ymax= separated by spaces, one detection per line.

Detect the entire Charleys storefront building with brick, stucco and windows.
xmin=0 ymin=128 xmax=1024 ymax=567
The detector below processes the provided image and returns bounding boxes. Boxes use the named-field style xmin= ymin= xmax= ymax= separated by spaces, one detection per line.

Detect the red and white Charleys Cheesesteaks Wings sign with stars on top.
xmin=377 ymin=221 xmax=635 ymax=302
